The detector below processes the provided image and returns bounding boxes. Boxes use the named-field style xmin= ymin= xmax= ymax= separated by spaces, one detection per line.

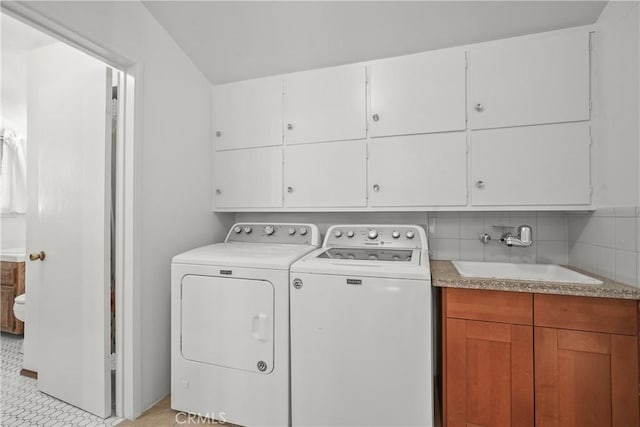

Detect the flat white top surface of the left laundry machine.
xmin=172 ymin=242 xmax=316 ymax=270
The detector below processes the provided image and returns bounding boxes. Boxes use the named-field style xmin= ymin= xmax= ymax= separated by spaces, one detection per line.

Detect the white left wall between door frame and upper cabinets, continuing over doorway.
xmin=11 ymin=1 xmax=232 ymax=409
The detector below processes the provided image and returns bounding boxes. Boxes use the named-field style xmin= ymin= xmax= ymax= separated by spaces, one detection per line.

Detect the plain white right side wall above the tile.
xmin=592 ymin=1 xmax=640 ymax=208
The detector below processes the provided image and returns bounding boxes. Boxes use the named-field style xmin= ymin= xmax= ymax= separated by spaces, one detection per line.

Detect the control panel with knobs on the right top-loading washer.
xmin=323 ymin=225 xmax=427 ymax=249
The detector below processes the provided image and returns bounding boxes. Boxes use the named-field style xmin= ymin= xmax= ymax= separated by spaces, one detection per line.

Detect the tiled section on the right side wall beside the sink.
xmin=567 ymin=206 xmax=640 ymax=287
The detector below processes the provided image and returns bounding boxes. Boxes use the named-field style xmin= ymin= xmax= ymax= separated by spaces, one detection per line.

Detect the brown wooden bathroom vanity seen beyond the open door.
xmin=0 ymin=261 xmax=24 ymax=334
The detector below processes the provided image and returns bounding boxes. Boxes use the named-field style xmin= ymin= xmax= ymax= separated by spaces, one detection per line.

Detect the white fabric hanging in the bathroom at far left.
xmin=0 ymin=129 xmax=27 ymax=213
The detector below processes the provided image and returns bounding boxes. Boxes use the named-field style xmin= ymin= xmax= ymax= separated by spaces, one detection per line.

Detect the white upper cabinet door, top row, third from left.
xmin=369 ymin=50 xmax=466 ymax=137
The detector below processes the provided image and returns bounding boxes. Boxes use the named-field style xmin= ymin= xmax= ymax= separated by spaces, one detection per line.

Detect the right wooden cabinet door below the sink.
xmin=535 ymin=327 xmax=639 ymax=427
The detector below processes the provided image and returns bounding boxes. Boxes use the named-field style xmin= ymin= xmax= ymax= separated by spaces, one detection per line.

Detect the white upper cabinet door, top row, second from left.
xmin=285 ymin=66 xmax=367 ymax=144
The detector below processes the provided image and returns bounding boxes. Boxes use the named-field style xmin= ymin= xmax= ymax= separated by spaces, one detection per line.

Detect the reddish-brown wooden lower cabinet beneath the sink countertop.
xmin=442 ymin=288 xmax=640 ymax=427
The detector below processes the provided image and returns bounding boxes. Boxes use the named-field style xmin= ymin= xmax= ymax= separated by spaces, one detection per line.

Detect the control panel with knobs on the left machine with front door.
xmin=225 ymin=223 xmax=320 ymax=246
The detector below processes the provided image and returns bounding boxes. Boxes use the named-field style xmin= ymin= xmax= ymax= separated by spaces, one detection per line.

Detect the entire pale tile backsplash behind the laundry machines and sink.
xmin=236 ymin=207 xmax=640 ymax=287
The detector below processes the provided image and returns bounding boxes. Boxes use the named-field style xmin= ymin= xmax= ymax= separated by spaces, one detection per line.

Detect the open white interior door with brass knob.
xmin=25 ymin=44 xmax=111 ymax=418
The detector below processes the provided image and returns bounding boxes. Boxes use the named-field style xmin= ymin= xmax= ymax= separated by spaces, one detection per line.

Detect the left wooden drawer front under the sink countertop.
xmin=442 ymin=288 xmax=533 ymax=325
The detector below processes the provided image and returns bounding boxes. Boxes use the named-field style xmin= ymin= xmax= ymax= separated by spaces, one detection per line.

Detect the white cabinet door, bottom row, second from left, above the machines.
xmin=285 ymin=142 xmax=367 ymax=207
